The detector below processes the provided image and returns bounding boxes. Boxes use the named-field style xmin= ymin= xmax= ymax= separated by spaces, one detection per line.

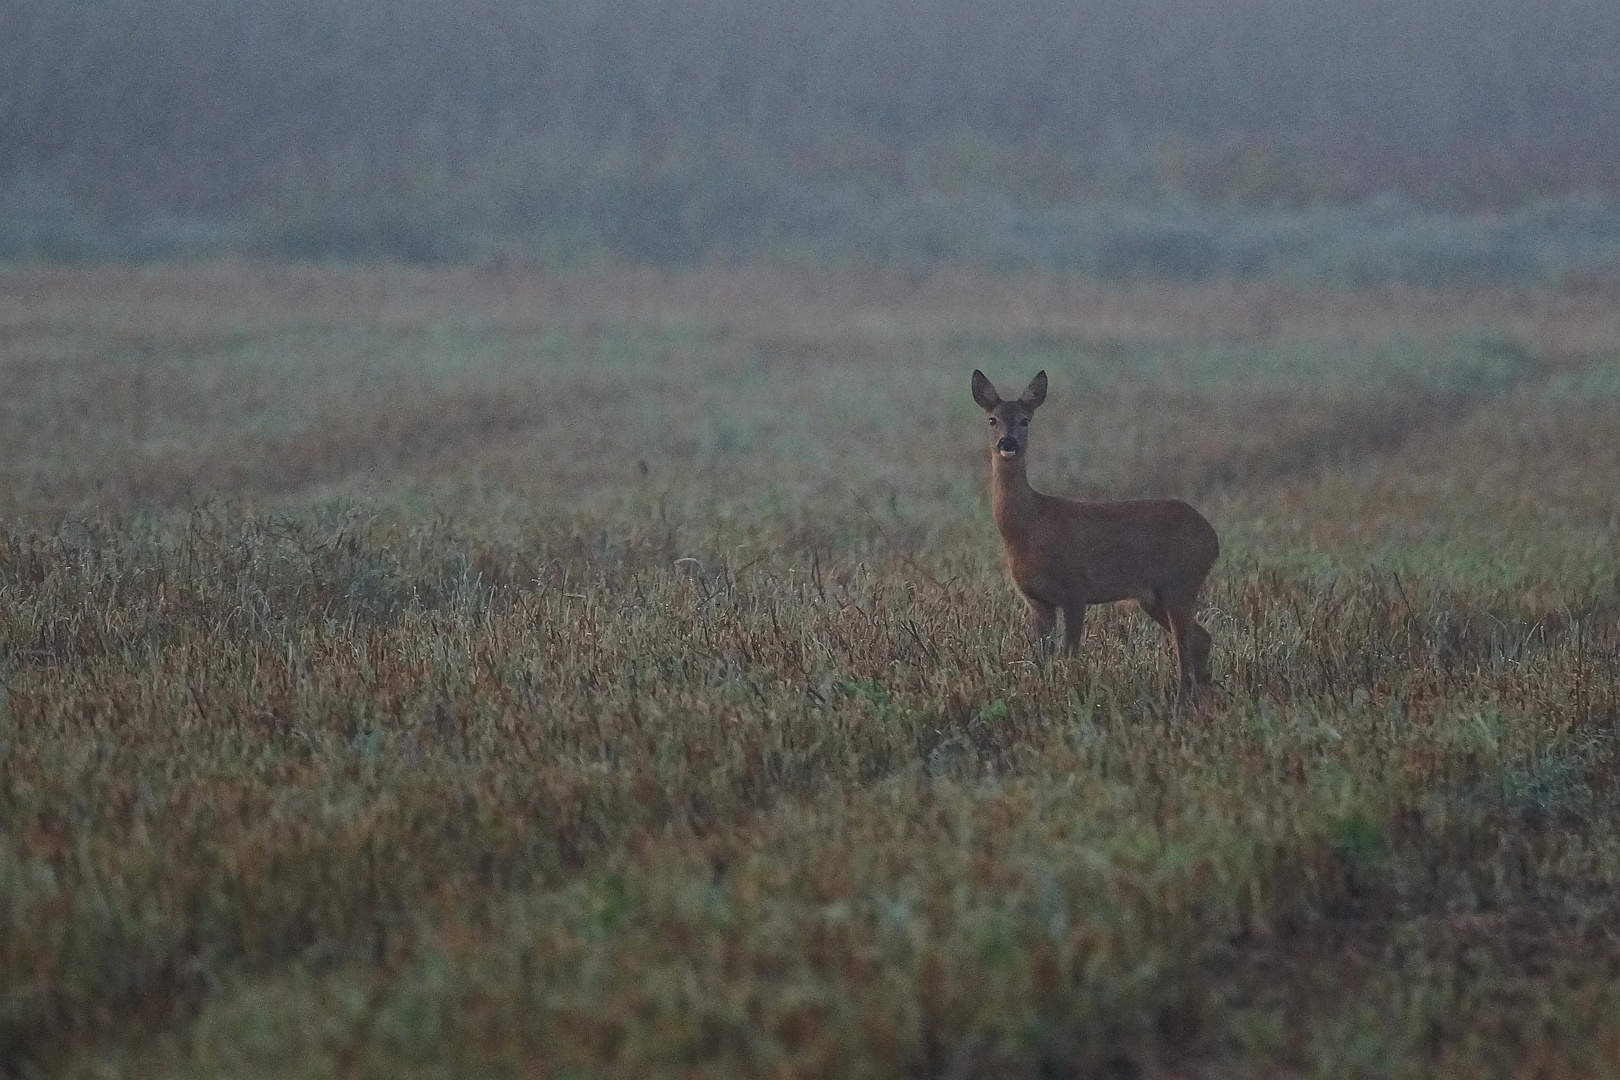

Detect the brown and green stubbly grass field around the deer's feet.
xmin=0 ymin=266 xmax=1620 ymax=1080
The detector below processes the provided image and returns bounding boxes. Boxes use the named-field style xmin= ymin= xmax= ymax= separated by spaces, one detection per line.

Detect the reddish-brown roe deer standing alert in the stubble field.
xmin=974 ymin=371 xmax=1220 ymax=687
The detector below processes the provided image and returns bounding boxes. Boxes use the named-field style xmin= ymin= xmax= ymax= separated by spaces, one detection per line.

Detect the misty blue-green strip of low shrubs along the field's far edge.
xmin=9 ymin=160 xmax=1620 ymax=290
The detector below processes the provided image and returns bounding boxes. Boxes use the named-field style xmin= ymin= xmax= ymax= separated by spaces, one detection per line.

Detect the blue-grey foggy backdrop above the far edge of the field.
xmin=0 ymin=0 xmax=1620 ymax=270
